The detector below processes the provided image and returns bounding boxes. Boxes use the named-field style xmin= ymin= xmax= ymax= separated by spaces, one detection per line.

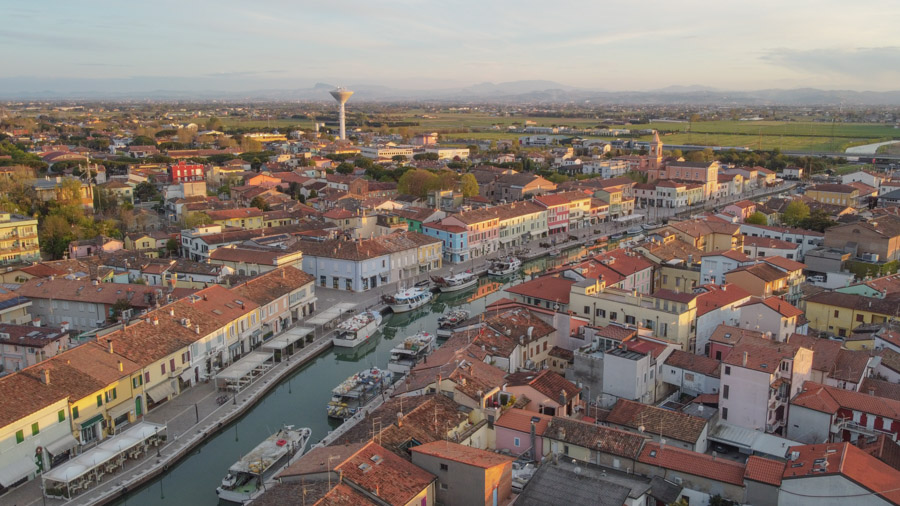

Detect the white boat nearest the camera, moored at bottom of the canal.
xmin=216 ymin=425 xmax=312 ymax=504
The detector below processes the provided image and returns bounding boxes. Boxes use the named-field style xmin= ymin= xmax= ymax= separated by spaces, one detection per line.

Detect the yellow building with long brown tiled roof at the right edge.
xmin=801 ymin=292 xmax=900 ymax=349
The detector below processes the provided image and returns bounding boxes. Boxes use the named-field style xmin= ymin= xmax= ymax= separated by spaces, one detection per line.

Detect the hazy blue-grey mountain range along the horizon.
xmin=0 ymin=76 xmax=900 ymax=106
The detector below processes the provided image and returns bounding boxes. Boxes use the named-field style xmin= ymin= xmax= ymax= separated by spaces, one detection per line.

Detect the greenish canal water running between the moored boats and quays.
xmin=116 ymin=247 xmax=585 ymax=506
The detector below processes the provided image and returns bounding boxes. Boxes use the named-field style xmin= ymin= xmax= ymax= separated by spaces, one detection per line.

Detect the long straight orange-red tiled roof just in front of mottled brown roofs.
xmin=638 ymin=442 xmax=745 ymax=486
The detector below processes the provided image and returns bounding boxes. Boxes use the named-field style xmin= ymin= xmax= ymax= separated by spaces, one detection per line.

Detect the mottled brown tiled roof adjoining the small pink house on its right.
xmin=544 ymin=416 xmax=648 ymax=459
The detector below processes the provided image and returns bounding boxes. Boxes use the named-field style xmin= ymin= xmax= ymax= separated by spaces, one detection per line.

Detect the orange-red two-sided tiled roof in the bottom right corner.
xmin=782 ymin=443 xmax=900 ymax=504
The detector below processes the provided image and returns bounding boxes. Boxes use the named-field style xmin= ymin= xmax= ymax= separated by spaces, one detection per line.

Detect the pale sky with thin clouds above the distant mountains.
xmin=0 ymin=0 xmax=900 ymax=92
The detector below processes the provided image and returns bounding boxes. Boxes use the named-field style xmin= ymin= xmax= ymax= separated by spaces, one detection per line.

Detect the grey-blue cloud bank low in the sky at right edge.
xmin=760 ymin=46 xmax=900 ymax=79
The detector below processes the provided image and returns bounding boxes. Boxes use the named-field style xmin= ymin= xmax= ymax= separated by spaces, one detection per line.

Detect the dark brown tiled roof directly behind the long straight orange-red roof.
xmin=606 ymin=399 xmax=707 ymax=444
